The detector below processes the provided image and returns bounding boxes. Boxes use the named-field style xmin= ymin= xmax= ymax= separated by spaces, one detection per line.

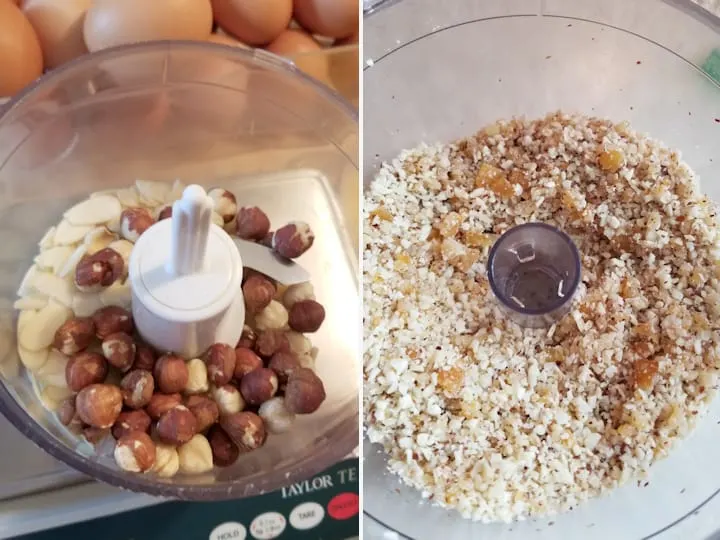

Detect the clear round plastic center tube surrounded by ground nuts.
xmin=488 ymin=223 xmax=580 ymax=328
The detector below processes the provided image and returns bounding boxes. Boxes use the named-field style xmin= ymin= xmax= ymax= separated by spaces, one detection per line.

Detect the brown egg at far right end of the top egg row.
xmin=293 ymin=0 xmax=360 ymax=38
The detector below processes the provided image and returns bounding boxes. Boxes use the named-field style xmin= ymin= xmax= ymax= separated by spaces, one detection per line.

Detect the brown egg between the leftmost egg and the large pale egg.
xmin=22 ymin=0 xmax=92 ymax=69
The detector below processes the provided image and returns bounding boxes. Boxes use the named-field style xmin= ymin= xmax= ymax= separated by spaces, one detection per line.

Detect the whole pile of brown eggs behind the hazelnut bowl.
xmin=0 ymin=0 xmax=359 ymax=97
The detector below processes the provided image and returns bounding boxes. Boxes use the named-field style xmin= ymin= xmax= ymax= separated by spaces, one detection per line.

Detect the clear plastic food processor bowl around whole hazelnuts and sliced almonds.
xmin=0 ymin=42 xmax=359 ymax=500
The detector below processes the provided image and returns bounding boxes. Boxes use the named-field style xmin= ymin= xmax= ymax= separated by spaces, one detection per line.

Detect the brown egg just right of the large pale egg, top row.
xmin=212 ymin=0 xmax=292 ymax=45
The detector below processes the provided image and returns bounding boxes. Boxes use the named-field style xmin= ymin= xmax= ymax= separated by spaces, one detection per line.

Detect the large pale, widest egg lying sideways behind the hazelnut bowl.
xmin=83 ymin=0 xmax=212 ymax=51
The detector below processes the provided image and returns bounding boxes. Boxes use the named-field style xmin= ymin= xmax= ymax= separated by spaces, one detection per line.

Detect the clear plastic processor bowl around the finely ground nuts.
xmin=363 ymin=0 xmax=720 ymax=540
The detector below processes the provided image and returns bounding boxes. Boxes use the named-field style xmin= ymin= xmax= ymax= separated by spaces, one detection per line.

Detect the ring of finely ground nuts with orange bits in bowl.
xmin=364 ymin=113 xmax=720 ymax=521
